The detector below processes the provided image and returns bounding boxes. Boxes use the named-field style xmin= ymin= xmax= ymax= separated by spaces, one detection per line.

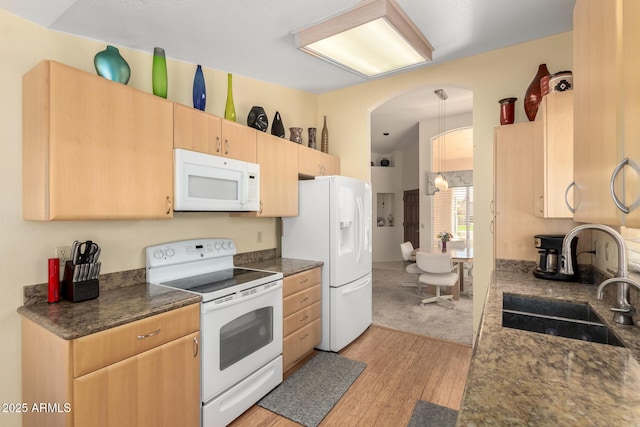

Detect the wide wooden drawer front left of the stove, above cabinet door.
xmin=72 ymin=304 xmax=200 ymax=378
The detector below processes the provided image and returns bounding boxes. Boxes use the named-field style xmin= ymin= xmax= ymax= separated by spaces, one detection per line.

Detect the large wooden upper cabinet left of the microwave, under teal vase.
xmin=22 ymin=60 xmax=173 ymax=221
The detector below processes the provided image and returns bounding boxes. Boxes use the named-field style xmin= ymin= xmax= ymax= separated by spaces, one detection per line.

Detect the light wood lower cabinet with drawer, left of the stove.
xmin=22 ymin=304 xmax=200 ymax=427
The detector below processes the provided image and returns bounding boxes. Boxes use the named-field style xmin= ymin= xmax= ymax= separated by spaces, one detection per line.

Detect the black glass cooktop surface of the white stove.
xmin=160 ymin=267 xmax=276 ymax=295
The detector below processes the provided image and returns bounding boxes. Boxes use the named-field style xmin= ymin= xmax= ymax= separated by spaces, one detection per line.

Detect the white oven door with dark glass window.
xmin=201 ymin=280 xmax=282 ymax=403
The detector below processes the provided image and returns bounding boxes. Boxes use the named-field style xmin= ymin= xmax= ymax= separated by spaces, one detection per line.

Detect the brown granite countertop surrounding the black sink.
xmin=457 ymin=271 xmax=640 ymax=426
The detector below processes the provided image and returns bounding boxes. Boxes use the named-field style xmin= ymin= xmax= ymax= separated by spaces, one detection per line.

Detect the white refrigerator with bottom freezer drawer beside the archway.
xmin=282 ymin=176 xmax=373 ymax=351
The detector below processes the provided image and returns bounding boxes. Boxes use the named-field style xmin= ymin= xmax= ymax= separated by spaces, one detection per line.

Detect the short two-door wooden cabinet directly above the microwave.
xmin=173 ymin=104 xmax=256 ymax=163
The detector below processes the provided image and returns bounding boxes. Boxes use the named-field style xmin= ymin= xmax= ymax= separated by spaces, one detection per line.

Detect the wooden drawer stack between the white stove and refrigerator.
xmin=282 ymin=267 xmax=322 ymax=372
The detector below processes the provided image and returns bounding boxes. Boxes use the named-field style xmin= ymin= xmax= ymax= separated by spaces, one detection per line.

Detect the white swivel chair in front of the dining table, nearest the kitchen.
xmin=416 ymin=252 xmax=458 ymax=308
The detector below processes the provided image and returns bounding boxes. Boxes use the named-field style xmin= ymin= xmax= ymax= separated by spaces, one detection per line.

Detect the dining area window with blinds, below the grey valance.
xmin=431 ymin=187 xmax=473 ymax=248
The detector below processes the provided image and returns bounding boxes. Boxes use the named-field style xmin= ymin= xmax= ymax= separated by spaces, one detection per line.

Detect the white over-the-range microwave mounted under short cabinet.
xmin=173 ymin=148 xmax=260 ymax=212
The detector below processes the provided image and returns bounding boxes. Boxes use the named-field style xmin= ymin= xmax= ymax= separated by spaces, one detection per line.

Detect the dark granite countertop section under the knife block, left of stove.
xmin=18 ymin=283 xmax=201 ymax=340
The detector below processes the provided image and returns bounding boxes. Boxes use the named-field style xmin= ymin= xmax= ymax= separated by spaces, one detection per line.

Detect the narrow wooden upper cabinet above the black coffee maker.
xmin=533 ymin=91 xmax=573 ymax=218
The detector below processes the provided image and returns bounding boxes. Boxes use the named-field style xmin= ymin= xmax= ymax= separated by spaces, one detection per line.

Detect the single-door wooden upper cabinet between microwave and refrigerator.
xmin=231 ymin=132 xmax=298 ymax=217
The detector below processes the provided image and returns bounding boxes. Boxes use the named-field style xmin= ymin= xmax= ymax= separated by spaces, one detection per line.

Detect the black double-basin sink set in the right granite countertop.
xmin=502 ymin=294 xmax=624 ymax=347
